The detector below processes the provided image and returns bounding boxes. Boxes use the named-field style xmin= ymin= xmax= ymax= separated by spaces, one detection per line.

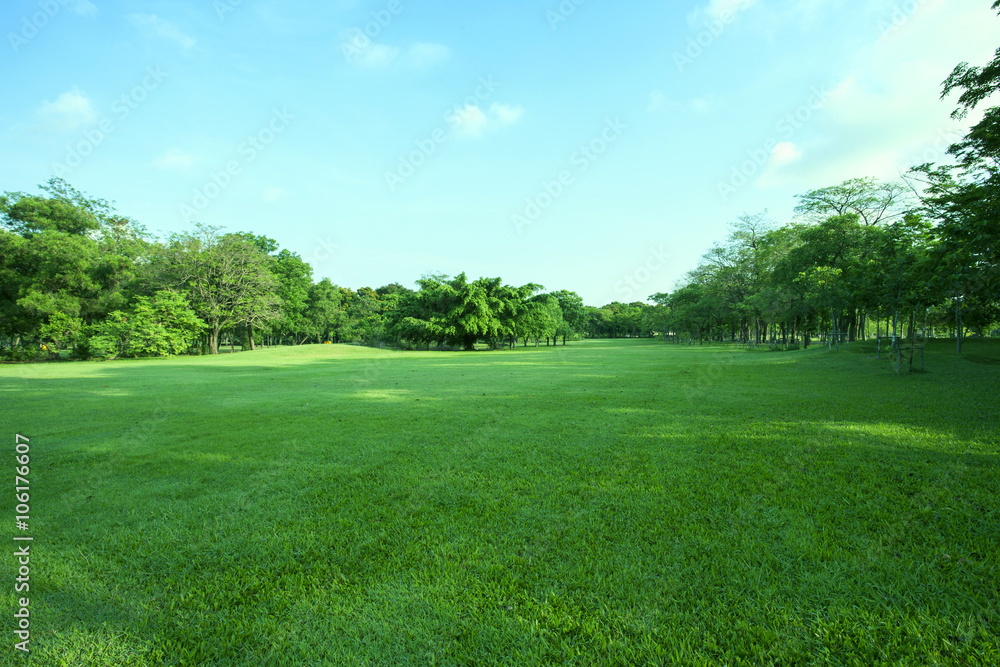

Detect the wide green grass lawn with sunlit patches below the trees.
xmin=0 ymin=341 xmax=1000 ymax=667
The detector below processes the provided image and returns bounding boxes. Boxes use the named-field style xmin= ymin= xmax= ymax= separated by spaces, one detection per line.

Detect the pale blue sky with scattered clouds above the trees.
xmin=0 ymin=0 xmax=1000 ymax=306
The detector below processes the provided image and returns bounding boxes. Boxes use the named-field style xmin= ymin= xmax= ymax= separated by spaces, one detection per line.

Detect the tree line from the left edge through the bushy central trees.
xmin=0 ymin=183 xmax=668 ymax=360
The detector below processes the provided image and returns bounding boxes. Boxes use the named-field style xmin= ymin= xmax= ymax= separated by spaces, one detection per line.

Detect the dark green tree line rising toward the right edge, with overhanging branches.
xmin=650 ymin=14 xmax=1000 ymax=352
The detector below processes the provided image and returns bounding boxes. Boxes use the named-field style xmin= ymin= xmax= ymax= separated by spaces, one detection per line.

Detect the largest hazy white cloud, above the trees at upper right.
xmin=758 ymin=0 xmax=996 ymax=189
